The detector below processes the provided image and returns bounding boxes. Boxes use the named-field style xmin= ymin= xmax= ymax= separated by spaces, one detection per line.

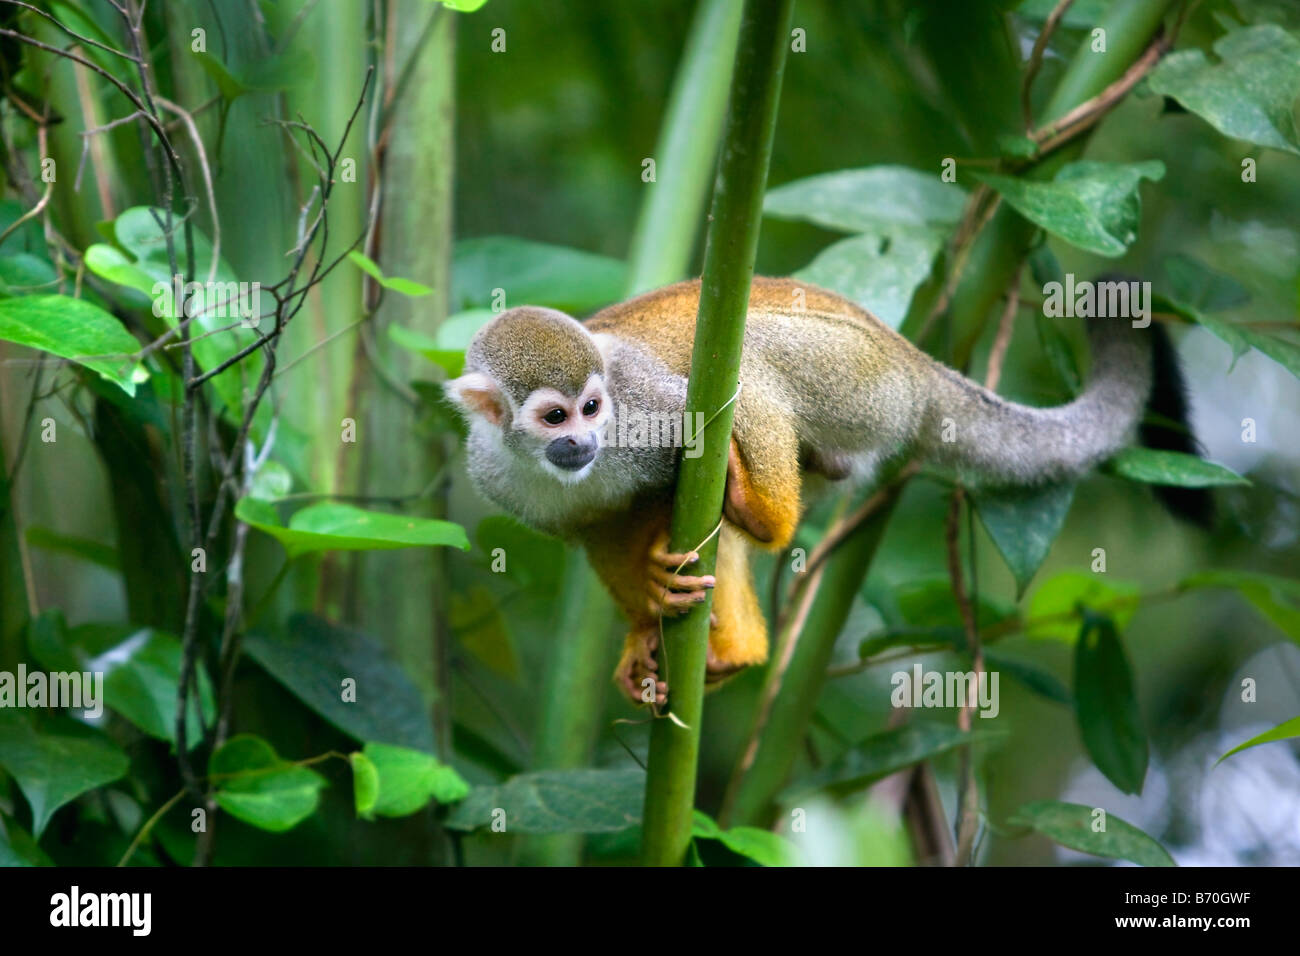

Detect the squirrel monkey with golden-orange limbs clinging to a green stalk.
xmin=446 ymin=278 xmax=1186 ymax=702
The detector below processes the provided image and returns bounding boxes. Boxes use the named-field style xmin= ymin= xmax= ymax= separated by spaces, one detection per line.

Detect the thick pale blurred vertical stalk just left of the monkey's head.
xmin=356 ymin=0 xmax=456 ymax=760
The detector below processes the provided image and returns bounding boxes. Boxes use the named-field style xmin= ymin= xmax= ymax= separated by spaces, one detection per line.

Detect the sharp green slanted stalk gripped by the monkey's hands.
xmin=641 ymin=0 xmax=794 ymax=866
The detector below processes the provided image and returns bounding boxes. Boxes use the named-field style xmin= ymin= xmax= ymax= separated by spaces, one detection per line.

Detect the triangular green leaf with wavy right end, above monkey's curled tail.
xmin=971 ymin=160 xmax=1165 ymax=258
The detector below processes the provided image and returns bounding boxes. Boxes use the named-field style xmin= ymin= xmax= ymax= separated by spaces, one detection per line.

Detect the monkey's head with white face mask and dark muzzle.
xmin=446 ymin=306 xmax=612 ymax=484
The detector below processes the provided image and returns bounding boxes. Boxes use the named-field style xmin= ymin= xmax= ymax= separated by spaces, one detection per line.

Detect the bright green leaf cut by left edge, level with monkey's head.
xmin=0 ymin=295 xmax=148 ymax=395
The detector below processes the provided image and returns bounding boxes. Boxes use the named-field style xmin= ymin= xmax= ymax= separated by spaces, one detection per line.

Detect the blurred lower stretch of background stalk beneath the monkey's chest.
xmin=517 ymin=549 xmax=619 ymax=866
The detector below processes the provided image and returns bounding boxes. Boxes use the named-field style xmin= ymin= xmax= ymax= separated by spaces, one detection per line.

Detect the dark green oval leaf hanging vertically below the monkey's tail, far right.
xmin=1074 ymin=614 xmax=1148 ymax=793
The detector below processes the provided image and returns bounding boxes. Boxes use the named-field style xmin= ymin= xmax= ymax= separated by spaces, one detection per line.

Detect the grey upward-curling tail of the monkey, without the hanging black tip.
xmin=922 ymin=317 xmax=1154 ymax=488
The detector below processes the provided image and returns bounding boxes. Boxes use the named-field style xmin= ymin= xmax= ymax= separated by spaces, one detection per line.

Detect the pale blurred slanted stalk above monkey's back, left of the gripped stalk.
xmin=628 ymin=0 xmax=741 ymax=295
